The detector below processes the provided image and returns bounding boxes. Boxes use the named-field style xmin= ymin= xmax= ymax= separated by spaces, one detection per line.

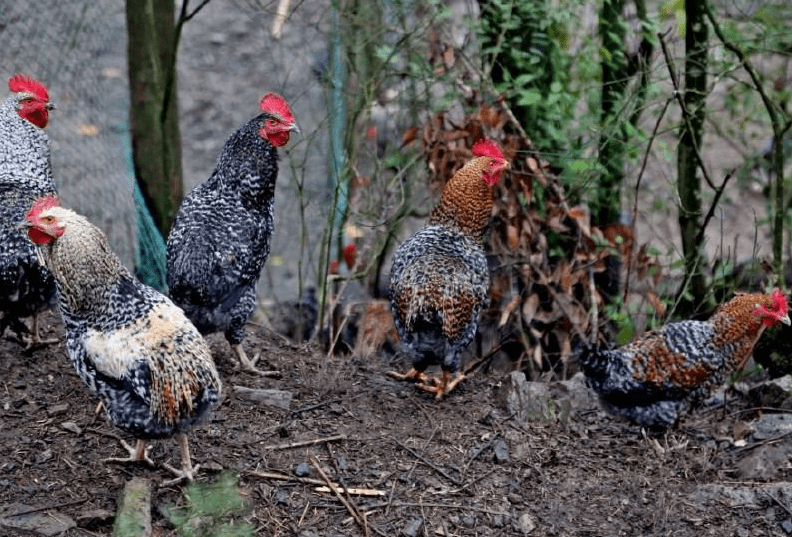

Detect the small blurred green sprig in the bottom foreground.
xmin=164 ymin=470 xmax=254 ymax=537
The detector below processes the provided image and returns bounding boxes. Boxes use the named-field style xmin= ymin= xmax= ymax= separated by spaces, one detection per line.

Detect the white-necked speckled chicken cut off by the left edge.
xmin=0 ymin=75 xmax=57 ymax=347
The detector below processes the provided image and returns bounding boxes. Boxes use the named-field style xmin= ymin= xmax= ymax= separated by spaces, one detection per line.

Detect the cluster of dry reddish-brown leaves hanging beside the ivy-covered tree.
xmin=414 ymin=106 xmax=662 ymax=378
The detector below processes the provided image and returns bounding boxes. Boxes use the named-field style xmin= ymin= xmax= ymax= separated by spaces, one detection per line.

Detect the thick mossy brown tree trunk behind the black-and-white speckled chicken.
xmin=126 ymin=0 xmax=184 ymax=237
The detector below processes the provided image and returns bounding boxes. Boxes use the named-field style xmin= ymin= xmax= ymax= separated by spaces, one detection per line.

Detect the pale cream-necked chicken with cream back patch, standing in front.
xmin=25 ymin=196 xmax=221 ymax=481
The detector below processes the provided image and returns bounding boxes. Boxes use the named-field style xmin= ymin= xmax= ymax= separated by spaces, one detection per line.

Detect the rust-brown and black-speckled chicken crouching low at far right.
xmin=578 ymin=290 xmax=789 ymax=430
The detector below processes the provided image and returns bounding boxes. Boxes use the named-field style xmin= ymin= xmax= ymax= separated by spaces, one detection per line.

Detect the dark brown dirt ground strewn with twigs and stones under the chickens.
xmin=0 ymin=314 xmax=792 ymax=537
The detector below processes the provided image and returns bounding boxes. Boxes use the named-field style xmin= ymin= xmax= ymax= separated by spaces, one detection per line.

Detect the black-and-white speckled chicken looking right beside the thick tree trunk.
xmin=167 ymin=93 xmax=299 ymax=373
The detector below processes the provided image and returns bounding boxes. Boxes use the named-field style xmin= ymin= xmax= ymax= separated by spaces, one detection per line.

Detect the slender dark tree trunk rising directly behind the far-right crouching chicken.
xmin=677 ymin=2 xmax=708 ymax=314
